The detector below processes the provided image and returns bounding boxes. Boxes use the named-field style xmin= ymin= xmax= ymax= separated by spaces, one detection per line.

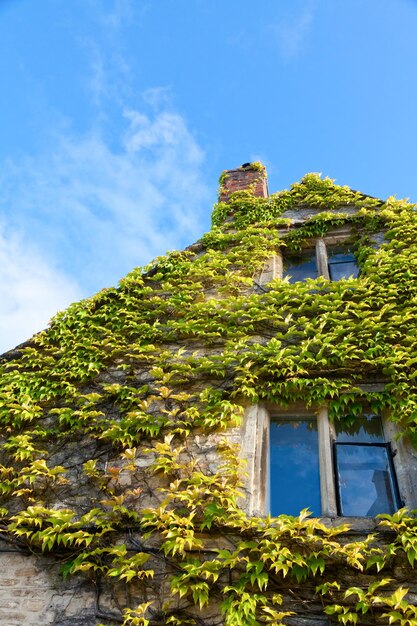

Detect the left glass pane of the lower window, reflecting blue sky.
xmin=269 ymin=418 xmax=321 ymax=516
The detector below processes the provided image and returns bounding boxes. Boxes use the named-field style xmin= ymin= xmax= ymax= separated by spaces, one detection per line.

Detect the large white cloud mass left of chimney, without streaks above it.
xmin=0 ymin=109 xmax=209 ymax=350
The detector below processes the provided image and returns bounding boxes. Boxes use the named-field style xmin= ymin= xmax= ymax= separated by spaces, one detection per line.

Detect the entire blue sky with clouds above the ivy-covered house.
xmin=0 ymin=0 xmax=417 ymax=351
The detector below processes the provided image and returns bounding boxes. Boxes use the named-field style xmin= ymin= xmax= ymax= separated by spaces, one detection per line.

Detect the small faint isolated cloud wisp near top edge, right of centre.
xmin=270 ymin=6 xmax=314 ymax=61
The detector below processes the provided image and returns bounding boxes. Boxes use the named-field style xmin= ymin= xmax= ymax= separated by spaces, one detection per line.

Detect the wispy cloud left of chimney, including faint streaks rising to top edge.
xmin=0 ymin=0 xmax=212 ymax=352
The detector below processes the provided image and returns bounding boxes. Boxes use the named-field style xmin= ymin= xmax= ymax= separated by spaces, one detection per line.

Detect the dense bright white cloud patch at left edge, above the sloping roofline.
xmin=0 ymin=227 xmax=81 ymax=353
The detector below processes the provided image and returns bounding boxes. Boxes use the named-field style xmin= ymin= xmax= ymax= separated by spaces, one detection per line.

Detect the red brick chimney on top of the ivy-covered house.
xmin=219 ymin=163 xmax=268 ymax=202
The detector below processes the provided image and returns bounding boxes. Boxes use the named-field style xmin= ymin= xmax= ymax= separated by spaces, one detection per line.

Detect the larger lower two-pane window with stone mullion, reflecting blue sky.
xmin=267 ymin=409 xmax=401 ymax=517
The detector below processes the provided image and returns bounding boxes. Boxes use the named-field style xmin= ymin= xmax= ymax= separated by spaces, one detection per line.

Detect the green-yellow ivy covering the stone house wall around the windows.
xmin=0 ymin=168 xmax=417 ymax=626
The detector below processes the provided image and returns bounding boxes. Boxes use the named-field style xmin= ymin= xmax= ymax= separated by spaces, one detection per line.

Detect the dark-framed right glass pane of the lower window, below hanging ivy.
xmin=336 ymin=444 xmax=397 ymax=517
